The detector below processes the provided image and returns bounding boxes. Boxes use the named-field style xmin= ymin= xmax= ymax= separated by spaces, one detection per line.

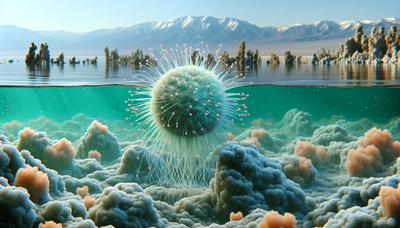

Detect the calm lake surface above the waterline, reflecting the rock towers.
xmin=0 ymin=61 xmax=400 ymax=86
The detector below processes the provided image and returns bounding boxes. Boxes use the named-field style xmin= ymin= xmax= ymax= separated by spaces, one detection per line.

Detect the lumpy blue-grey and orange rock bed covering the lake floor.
xmin=0 ymin=110 xmax=400 ymax=228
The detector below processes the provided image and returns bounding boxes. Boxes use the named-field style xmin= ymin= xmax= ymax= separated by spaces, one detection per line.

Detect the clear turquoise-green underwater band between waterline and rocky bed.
xmin=0 ymin=86 xmax=400 ymax=122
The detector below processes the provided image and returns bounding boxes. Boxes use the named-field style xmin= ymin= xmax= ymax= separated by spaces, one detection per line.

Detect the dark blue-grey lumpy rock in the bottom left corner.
xmin=0 ymin=186 xmax=36 ymax=227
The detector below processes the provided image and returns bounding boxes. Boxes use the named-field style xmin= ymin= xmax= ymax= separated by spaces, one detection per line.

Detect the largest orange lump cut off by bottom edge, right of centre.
xmin=258 ymin=211 xmax=296 ymax=228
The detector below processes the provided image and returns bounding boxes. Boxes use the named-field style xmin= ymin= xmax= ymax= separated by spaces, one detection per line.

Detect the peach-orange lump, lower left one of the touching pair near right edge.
xmin=345 ymin=145 xmax=383 ymax=177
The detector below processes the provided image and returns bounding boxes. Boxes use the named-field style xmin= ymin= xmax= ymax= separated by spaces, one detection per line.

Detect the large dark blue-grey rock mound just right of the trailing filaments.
xmin=212 ymin=144 xmax=307 ymax=218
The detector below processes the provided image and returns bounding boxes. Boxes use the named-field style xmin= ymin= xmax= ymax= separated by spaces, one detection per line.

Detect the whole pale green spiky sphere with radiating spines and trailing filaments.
xmin=126 ymin=48 xmax=248 ymax=185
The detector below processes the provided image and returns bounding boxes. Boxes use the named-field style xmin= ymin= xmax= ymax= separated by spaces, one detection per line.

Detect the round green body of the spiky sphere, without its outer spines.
xmin=151 ymin=65 xmax=226 ymax=137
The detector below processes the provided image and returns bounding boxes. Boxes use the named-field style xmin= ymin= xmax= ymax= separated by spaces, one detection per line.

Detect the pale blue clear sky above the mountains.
xmin=0 ymin=0 xmax=400 ymax=32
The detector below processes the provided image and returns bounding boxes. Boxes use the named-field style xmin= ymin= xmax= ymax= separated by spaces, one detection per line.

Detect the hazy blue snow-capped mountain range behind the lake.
xmin=0 ymin=16 xmax=400 ymax=56
